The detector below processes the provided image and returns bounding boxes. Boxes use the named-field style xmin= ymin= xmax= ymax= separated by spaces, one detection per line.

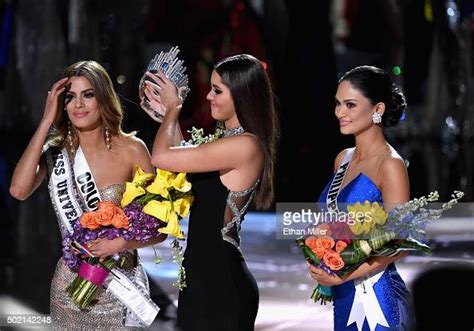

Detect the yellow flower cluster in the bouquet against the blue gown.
xmin=347 ymin=200 xmax=388 ymax=235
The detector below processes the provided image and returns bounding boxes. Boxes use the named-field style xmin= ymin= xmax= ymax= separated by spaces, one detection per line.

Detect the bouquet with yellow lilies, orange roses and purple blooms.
xmin=63 ymin=167 xmax=193 ymax=309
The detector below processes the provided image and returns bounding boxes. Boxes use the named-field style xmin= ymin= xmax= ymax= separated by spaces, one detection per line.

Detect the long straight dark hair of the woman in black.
xmin=214 ymin=54 xmax=279 ymax=209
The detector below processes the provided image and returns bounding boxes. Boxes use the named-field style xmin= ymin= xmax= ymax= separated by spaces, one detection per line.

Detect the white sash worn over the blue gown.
xmin=326 ymin=148 xmax=389 ymax=331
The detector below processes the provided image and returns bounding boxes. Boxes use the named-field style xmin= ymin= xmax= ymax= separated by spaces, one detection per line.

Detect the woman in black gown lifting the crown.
xmin=145 ymin=54 xmax=278 ymax=331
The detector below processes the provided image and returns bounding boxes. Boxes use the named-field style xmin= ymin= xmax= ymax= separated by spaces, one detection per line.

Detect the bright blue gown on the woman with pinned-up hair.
xmin=319 ymin=173 xmax=413 ymax=331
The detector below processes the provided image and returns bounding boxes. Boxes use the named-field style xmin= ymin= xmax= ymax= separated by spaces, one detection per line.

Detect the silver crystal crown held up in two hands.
xmin=139 ymin=46 xmax=190 ymax=121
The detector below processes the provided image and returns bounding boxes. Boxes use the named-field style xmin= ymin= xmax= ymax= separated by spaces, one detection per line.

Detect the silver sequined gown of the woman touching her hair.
xmin=50 ymin=184 xmax=141 ymax=331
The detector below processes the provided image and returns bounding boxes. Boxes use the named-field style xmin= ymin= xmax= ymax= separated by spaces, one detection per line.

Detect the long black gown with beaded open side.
xmin=178 ymin=172 xmax=259 ymax=331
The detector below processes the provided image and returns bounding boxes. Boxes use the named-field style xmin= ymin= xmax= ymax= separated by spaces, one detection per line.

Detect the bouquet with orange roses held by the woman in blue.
xmin=297 ymin=191 xmax=464 ymax=304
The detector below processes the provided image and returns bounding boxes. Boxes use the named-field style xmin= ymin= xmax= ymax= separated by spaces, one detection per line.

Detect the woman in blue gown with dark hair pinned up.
xmin=309 ymin=66 xmax=413 ymax=330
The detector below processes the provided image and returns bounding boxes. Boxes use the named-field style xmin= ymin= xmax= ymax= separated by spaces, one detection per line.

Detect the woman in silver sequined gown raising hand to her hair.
xmin=10 ymin=61 xmax=164 ymax=330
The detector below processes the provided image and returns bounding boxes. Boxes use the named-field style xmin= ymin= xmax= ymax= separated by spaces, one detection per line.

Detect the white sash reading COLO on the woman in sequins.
xmin=43 ymin=144 xmax=160 ymax=327
